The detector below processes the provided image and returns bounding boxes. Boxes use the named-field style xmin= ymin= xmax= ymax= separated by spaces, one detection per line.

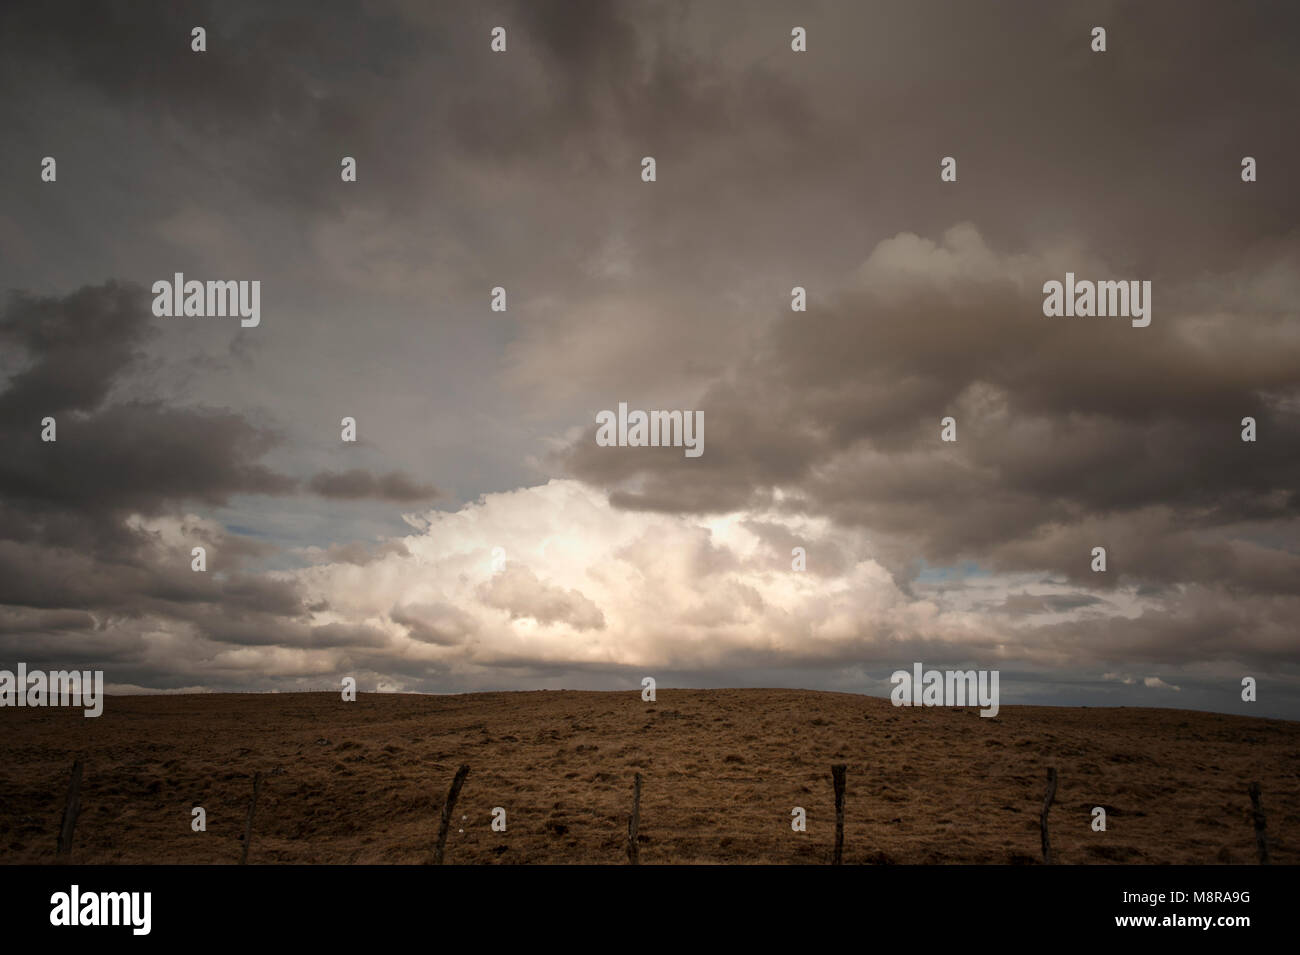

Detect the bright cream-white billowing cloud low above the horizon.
xmin=279 ymin=479 xmax=1144 ymax=672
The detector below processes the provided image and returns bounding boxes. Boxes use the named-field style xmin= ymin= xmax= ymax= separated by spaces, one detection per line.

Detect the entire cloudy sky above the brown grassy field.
xmin=0 ymin=0 xmax=1300 ymax=719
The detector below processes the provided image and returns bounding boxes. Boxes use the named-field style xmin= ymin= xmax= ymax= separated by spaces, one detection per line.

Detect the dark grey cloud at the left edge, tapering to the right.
xmin=0 ymin=283 xmax=295 ymax=561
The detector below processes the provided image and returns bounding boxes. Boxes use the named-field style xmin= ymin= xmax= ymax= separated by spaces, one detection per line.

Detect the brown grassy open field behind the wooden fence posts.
xmin=0 ymin=690 xmax=1300 ymax=864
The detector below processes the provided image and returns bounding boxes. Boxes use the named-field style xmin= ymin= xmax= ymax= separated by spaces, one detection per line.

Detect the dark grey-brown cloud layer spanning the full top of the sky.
xmin=0 ymin=0 xmax=1300 ymax=288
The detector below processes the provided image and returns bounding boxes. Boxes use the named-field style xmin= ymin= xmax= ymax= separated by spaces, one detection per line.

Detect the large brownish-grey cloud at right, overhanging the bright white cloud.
xmin=567 ymin=227 xmax=1300 ymax=592
